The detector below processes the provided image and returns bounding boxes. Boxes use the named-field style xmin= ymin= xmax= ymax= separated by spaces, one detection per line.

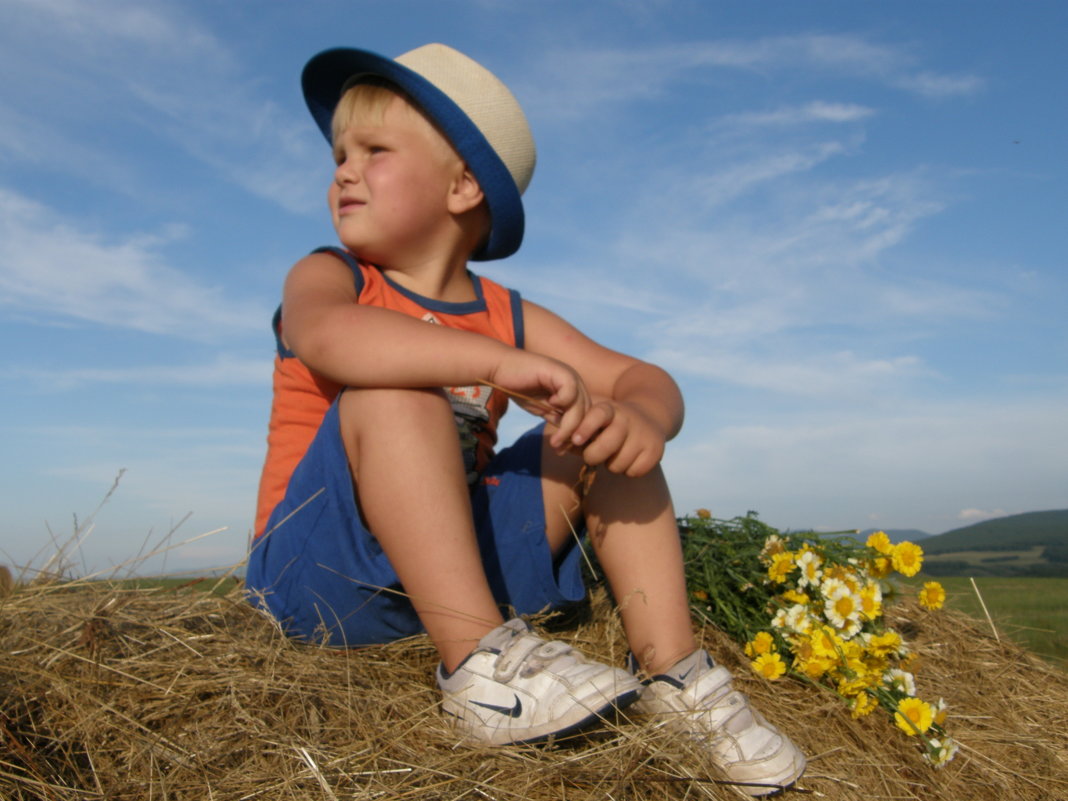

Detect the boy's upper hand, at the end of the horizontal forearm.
xmin=491 ymin=350 xmax=591 ymax=451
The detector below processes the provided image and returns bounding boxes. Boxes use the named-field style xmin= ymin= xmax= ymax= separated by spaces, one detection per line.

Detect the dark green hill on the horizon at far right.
xmin=909 ymin=509 xmax=1068 ymax=576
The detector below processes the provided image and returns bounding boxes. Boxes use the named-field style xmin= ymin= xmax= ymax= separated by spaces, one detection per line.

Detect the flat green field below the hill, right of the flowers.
xmin=908 ymin=576 xmax=1068 ymax=669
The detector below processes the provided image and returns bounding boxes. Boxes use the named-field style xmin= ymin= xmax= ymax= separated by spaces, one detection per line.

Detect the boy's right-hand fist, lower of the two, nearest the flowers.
xmin=569 ymin=399 xmax=666 ymax=478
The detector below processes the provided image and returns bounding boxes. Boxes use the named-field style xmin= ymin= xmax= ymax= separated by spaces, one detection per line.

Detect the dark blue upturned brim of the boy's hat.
xmin=300 ymin=47 xmax=524 ymax=261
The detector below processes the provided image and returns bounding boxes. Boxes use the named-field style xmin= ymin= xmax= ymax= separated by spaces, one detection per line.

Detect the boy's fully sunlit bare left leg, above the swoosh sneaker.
xmin=340 ymin=389 xmax=503 ymax=671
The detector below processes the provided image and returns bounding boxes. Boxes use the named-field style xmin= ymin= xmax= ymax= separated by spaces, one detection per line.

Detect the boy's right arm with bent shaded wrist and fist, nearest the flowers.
xmin=523 ymin=301 xmax=684 ymax=476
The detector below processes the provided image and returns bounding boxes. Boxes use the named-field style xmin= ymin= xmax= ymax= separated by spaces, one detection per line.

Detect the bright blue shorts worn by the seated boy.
xmin=246 ymin=401 xmax=585 ymax=647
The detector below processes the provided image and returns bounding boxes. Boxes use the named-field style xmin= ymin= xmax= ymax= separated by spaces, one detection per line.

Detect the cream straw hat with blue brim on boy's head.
xmin=301 ymin=44 xmax=535 ymax=261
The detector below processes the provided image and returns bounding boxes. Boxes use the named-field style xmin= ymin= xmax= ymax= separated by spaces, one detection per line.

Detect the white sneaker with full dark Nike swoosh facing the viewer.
xmin=438 ymin=618 xmax=642 ymax=745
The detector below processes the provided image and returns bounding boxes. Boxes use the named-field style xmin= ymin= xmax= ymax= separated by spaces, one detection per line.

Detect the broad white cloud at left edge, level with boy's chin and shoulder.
xmin=0 ymin=187 xmax=269 ymax=339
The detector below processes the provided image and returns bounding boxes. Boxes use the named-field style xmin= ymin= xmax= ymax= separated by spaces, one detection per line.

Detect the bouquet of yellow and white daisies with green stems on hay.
xmin=679 ymin=509 xmax=958 ymax=767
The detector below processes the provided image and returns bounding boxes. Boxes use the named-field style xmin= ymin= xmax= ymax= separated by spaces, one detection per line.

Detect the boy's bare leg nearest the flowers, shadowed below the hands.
xmin=541 ymin=441 xmax=696 ymax=675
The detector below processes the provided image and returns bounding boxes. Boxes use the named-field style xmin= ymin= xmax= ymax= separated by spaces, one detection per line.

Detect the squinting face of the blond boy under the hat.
xmin=327 ymin=92 xmax=464 ymax=267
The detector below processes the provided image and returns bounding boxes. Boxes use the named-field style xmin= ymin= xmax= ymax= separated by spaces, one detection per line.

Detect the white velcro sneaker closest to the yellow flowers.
xmin=634 ymin=650 xmax=805 ymax=796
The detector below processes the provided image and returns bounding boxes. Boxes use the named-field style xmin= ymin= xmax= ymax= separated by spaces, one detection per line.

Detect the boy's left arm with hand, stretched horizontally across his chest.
xmin=282 ymin=253 xmax=588 ymax=428
